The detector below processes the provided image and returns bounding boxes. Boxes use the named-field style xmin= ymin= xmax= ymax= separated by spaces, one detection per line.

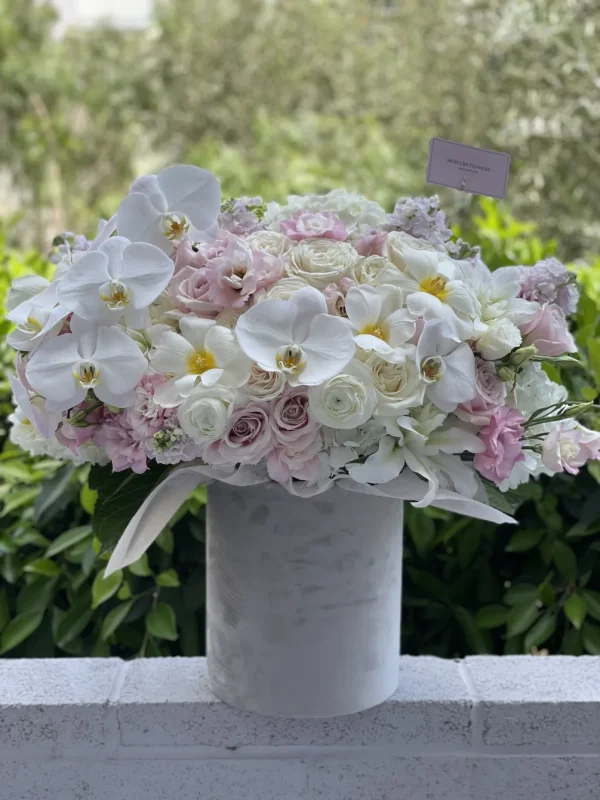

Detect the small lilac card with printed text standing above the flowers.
xmin=427 ymin=137 xmax=510 ymax=199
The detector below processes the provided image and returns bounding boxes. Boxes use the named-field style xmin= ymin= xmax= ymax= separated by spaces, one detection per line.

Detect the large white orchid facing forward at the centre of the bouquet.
xmin=235 ymin=286 xmax=356 ymax=386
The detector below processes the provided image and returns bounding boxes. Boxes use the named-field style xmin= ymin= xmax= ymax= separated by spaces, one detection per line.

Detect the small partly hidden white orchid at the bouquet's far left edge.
xmin=6 ymin=282 xmax=69 ymax=352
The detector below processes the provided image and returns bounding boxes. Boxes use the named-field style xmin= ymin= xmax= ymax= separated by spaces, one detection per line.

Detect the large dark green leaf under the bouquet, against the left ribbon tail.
xmin=89 ymin=464 xmax=170 ymax=550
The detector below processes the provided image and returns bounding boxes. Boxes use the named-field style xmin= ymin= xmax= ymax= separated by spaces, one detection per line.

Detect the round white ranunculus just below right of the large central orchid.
xmin=308 ymin=361 xmax=377 ymax=429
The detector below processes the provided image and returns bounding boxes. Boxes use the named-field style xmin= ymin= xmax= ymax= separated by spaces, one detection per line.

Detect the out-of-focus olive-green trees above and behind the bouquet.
xmin=0 ymin=0 xmax=600 ymax=259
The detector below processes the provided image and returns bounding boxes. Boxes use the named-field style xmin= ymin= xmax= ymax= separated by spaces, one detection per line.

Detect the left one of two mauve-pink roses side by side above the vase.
xmin=203 ymin=403 xmax=273 ymax=464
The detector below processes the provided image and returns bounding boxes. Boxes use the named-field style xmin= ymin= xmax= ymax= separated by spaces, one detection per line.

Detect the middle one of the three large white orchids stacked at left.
xmin=57 ymin=236 xmax=175 ymax=328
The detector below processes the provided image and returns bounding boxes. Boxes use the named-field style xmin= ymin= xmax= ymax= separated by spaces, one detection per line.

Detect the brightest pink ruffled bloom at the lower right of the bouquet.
xmin=473 ymin=406 xmax=525 ymax=483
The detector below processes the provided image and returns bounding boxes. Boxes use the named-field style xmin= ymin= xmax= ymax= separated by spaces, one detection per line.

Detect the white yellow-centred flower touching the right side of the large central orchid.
xmin=345 ymin=285 xmax=417 ymax=363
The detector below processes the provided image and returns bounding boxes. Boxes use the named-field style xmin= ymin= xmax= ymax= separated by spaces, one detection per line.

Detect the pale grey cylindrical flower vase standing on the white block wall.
xmin=207 ymin=483 xmax=403 ymax=717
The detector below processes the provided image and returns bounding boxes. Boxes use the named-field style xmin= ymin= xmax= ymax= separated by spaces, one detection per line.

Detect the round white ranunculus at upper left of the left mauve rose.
xmin=177 ymin=384 xmax=234 ymax=444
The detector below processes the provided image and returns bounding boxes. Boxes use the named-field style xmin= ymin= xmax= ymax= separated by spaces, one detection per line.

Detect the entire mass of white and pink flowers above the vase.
xmin=8 ymin=165 xmax=600 ymax=506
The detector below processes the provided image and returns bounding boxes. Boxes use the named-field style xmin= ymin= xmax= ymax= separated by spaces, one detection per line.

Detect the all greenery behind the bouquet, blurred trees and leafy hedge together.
xmin=0 ymin=0 xmax=600 ymax=658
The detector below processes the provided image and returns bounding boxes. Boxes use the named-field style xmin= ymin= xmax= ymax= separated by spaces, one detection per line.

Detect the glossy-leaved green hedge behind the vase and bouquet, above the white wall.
xmin=0 ymin=201 xmax=600 ymax=658
